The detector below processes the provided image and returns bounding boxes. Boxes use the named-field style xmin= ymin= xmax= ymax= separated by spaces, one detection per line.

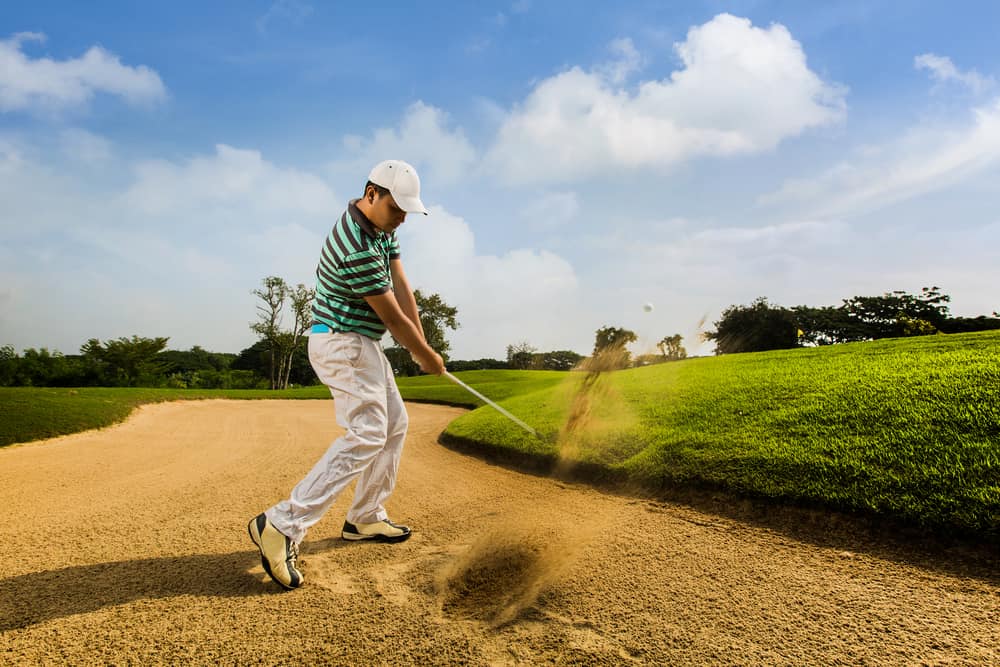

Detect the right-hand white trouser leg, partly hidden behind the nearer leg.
xmin=347 ymin=348 xmax=409 ymax=523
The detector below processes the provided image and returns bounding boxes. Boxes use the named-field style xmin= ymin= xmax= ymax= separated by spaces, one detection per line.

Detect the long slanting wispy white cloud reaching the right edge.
xmin=759 ymin=98 xmax=1000 ymax=217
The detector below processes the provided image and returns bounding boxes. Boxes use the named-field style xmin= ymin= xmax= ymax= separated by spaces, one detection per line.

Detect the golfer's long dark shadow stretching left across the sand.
xmin=0 ymin=551 xmax=272 ymax=632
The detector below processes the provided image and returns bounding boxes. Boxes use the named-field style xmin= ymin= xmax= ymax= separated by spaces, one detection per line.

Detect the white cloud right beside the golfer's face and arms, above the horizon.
xmin=399 ymin=206 xmax=592 ymax=359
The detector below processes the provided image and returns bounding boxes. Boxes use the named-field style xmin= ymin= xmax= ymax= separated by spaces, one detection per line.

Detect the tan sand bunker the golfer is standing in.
xmin=0 ymin=401 xmax=1000 ymax=665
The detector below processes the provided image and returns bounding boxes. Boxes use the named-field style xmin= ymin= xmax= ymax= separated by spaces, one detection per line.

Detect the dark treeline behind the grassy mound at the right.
xmin=704 ymin=286 xmax=1000 ymax=354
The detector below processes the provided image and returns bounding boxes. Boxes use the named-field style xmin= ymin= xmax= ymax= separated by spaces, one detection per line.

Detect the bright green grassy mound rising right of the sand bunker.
xmin=446 ymin=332 xmax=1000 ymax=538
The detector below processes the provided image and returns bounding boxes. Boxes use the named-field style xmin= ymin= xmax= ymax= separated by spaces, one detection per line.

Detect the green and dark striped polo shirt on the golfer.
xmin=313 ymin=199 xmax=399 ymax=340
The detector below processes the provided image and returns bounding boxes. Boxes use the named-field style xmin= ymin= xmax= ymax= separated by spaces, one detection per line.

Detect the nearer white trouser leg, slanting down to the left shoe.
xmin=266 ymin=333 xmax=395 ymax=543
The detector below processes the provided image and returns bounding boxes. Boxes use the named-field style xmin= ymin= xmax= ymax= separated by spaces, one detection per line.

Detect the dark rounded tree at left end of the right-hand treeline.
xmin=704 ymin=297 xmax=799 ymax=354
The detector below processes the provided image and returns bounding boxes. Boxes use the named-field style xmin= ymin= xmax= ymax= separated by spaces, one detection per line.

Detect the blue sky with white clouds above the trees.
xmin=0 ymin=0 xmax=1000 ymax=359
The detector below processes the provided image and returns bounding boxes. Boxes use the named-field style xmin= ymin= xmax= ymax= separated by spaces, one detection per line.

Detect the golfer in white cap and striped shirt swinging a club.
xmin=248 ymin=160 xmax=445 ymax=589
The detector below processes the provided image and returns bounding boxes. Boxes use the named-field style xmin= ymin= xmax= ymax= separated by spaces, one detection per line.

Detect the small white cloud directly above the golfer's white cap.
xmin=331 ymin=101 xmax=476 ymax=184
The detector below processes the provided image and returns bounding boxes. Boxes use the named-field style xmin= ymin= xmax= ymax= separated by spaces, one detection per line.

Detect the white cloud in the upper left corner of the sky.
xmin=0 ymin=33 xmax=167 ymax=112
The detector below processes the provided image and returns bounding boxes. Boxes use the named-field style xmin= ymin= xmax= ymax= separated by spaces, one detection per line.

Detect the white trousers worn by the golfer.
xmin=266 ymin=333 xmax=408 ymax=543
